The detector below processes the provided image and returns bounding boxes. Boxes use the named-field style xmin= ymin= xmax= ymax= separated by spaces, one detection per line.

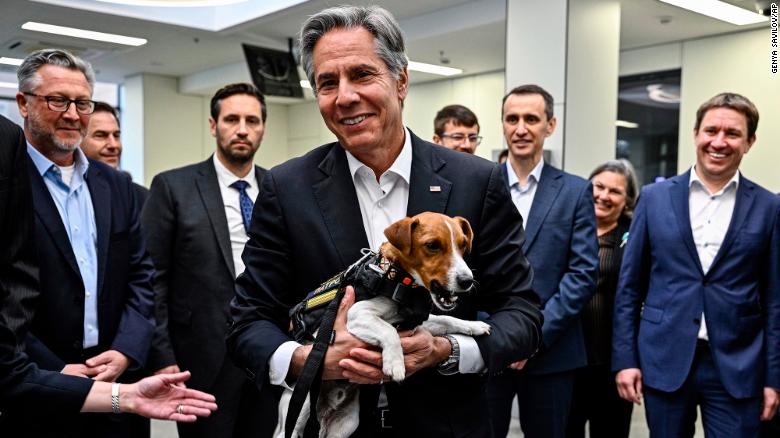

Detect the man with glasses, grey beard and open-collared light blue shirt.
xmin=4 ymin=49 xmax=154 ymax=437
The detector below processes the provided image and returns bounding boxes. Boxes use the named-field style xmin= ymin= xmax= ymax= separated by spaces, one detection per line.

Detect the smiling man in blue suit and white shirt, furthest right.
xmin=612 ymin=93 xmax=780 ymax=437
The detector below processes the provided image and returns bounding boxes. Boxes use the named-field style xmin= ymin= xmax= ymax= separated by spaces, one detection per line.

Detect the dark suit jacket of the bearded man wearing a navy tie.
xmin=143 ymin=158 xmax=266 ymax=390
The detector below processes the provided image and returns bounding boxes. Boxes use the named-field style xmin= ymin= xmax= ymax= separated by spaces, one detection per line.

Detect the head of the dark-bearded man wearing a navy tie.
xmin=209 ymin=94 xmax=265 ymax=164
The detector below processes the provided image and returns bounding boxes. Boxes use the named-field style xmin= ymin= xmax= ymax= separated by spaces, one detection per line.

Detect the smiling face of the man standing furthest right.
xmin=694 ymin=107 xmax=756 ymax=189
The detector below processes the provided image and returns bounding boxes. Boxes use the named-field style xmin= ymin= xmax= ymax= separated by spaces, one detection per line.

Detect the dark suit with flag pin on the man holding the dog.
xmin=228 ymin=135 xmax=541 ymax=436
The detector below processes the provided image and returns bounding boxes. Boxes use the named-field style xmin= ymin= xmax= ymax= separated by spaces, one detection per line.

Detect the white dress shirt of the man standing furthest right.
xmin=688 ymin=166 xmax=739 ymax=341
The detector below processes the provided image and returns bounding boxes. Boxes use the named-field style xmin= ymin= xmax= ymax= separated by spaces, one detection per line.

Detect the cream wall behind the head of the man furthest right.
xmin=620 ymin=29 xmax=780 ymax=192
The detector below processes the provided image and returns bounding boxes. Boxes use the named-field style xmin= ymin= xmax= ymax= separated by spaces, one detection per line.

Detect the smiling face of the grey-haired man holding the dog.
xmin=312 ymin=27 xmax=408 ymax=156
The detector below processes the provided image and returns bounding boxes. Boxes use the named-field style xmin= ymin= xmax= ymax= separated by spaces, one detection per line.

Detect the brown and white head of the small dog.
xmin=382 ymin=212 xmax=474 ymax=312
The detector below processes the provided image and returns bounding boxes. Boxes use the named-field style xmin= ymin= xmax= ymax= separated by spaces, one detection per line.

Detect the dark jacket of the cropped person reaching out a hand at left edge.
xmin=0 ymin=116 xmax=92 ymax=408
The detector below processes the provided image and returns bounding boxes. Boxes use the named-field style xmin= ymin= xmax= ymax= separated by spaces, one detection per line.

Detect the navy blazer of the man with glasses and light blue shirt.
xmin=27 ymin=154 xmax=154 ymax=371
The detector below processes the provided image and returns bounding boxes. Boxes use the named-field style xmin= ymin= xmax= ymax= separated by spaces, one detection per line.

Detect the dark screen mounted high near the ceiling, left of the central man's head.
xmin=242 ymin=44 xmax=303 ymax=97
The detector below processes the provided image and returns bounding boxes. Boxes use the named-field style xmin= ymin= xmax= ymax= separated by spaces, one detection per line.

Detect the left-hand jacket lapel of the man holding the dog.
xmin=312 ymin=143 xmax=376 ymax=266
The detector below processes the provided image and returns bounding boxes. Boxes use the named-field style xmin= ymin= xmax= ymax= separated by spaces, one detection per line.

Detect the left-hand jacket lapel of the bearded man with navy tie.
xmin=195 ymin=158 xmax=236 ymax=278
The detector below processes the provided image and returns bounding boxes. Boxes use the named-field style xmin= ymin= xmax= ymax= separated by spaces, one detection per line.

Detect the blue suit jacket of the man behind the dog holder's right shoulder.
xmin=501 ymin=164 xmax=599 ymax=374
